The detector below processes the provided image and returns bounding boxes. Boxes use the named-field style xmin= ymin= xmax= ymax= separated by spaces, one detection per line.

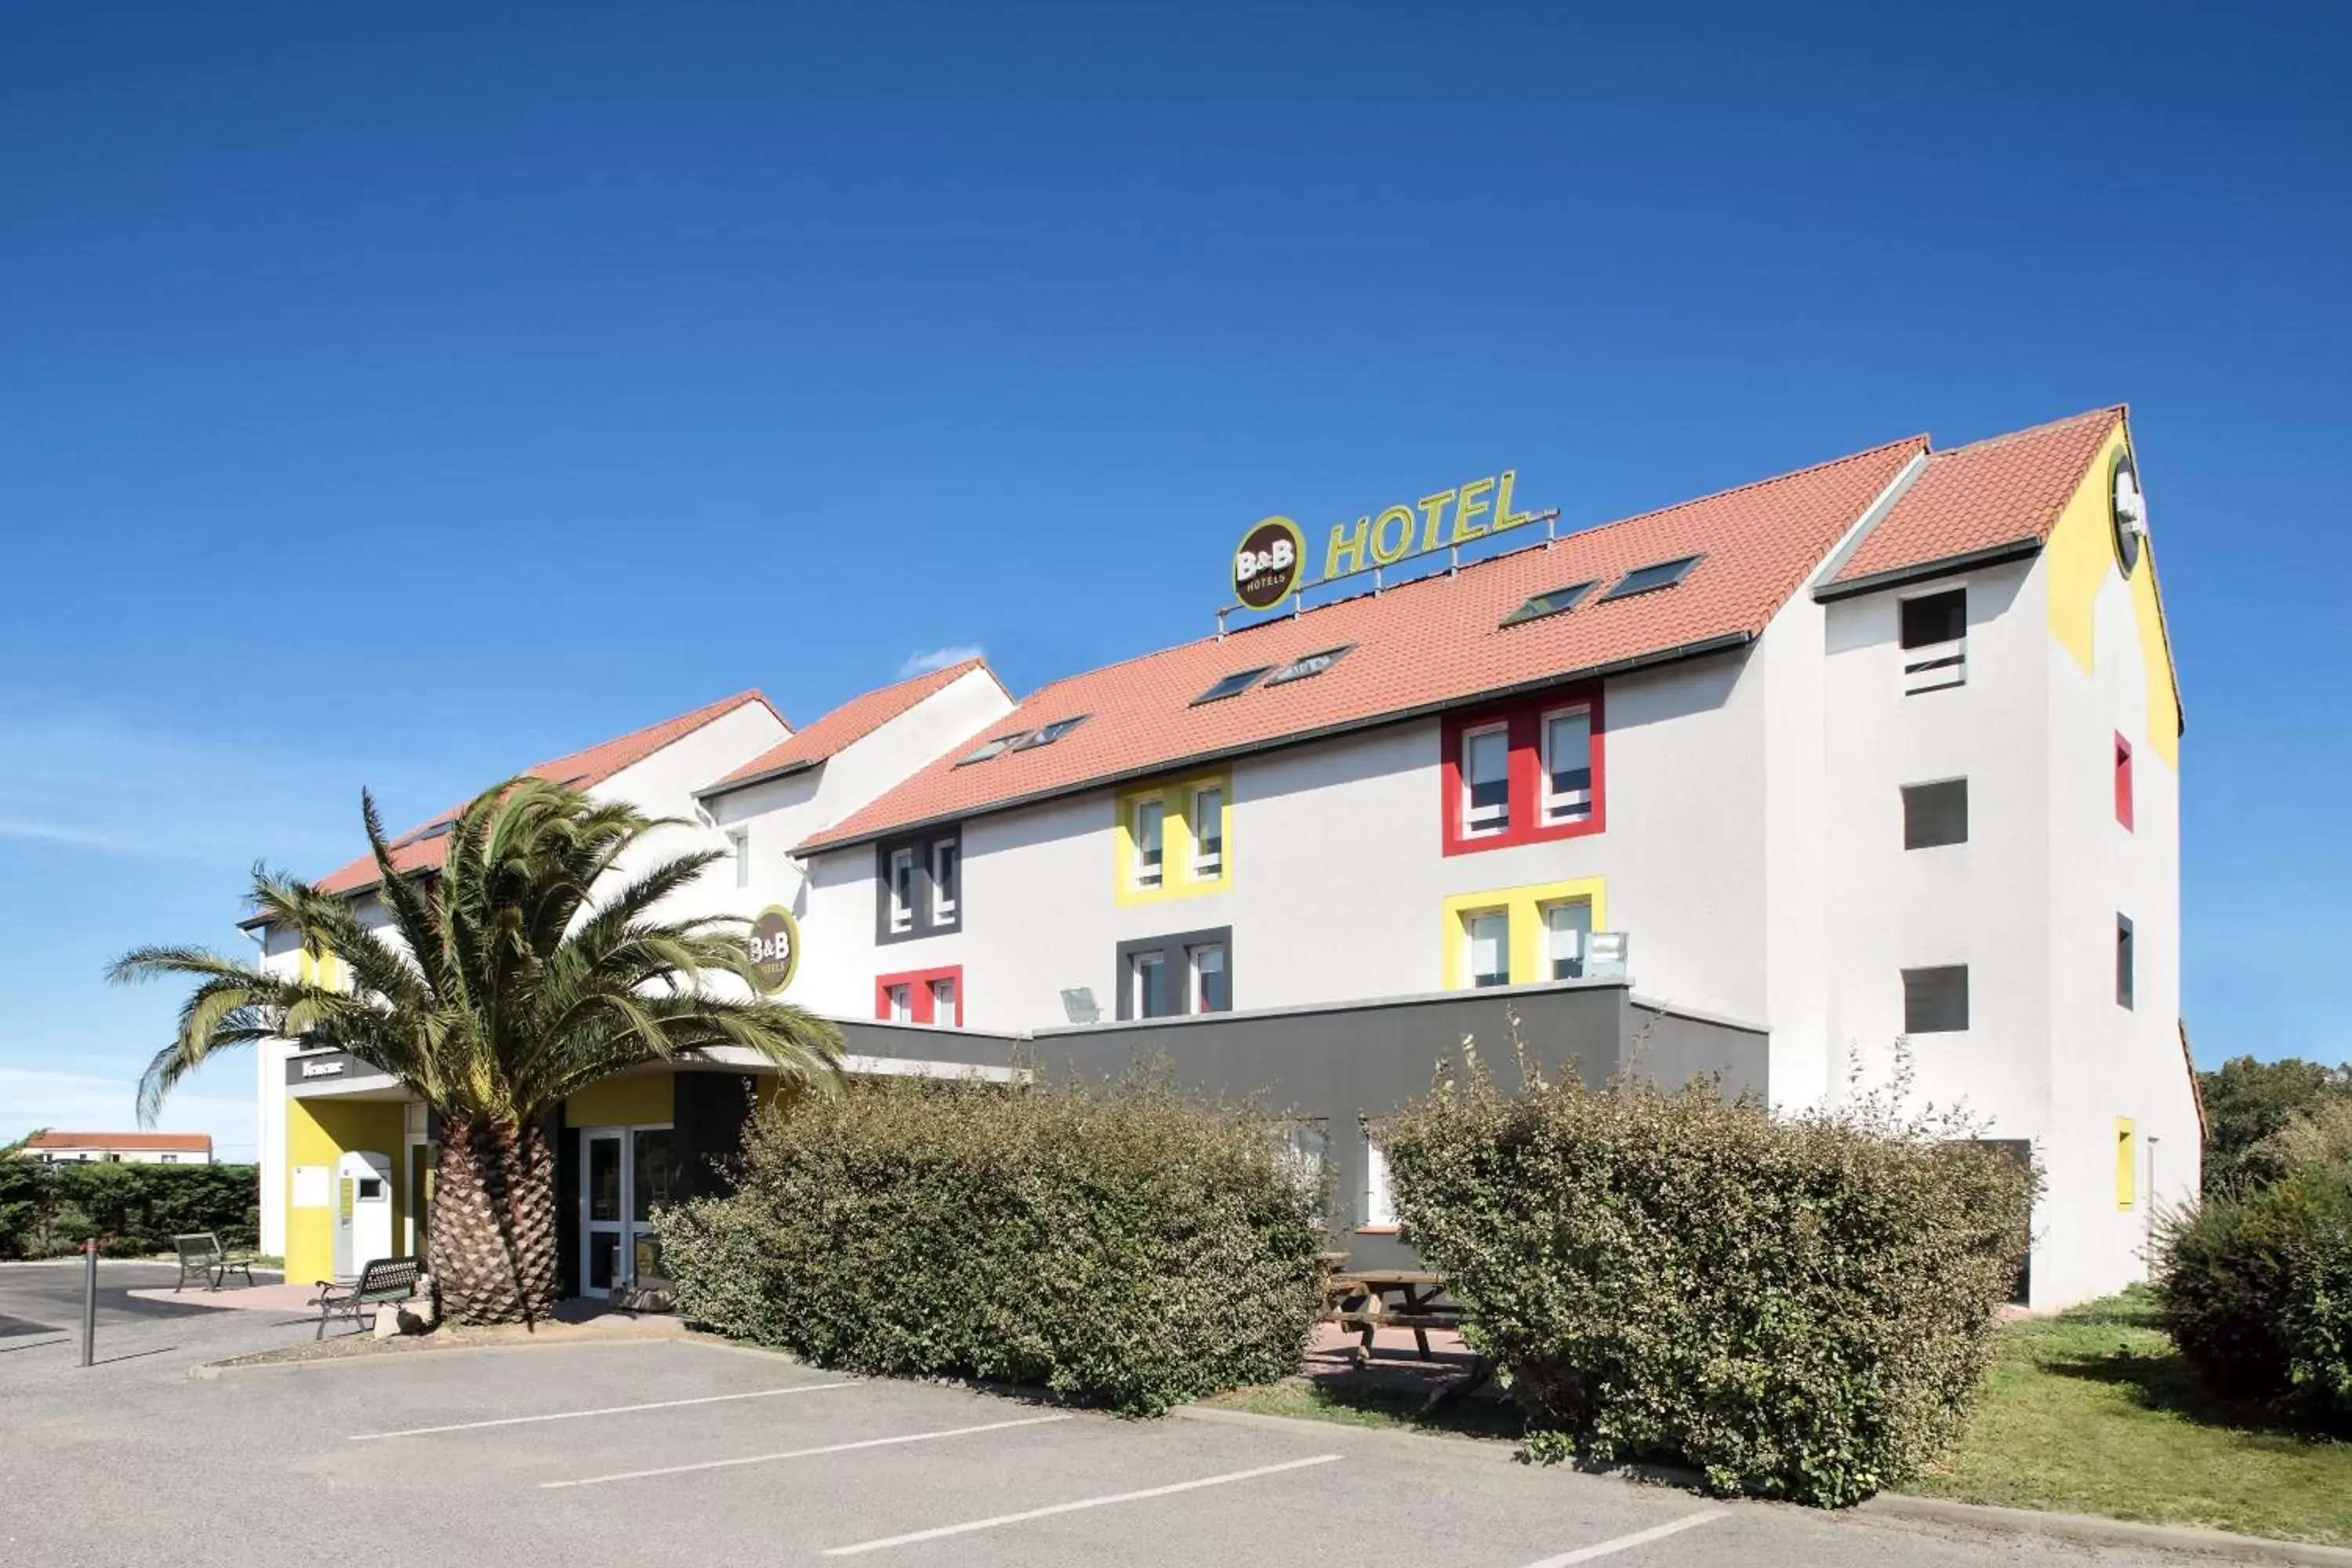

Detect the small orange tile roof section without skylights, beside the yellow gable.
xmin=1830 ymin=407 xmax=2124 ymax=583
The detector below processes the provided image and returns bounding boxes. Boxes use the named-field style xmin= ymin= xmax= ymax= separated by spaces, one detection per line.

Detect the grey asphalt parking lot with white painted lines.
xmin=0 ymin=1314 xmax=2176 ymax=1568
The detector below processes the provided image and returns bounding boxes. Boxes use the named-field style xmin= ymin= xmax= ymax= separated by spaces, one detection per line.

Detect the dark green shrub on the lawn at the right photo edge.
xmin=2157 ymin=1161 xmax=2352 ymax=1436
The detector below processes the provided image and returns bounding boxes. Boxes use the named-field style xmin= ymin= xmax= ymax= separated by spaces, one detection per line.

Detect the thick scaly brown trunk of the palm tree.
xmin=426 ymin=1114 xmax=557 ymax=1323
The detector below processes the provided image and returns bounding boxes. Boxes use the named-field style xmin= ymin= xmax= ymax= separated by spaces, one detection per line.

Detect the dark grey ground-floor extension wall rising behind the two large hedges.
xmin=842 ymin=982 xmax=1769 ymax=1267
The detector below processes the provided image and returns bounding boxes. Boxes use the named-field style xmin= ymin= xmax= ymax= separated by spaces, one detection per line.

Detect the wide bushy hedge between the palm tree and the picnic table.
xmin=656 ymin=1079 xmax=1319 ymax=1415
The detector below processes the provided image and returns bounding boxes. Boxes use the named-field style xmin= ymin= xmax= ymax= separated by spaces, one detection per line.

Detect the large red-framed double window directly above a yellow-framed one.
xmin=1439 ymin=684 xmax=1606 ymax=855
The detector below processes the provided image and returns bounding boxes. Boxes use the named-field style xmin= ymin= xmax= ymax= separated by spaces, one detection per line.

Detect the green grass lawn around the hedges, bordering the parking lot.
xmin=1209 ymin=1293 xmax=2352 ymax=1547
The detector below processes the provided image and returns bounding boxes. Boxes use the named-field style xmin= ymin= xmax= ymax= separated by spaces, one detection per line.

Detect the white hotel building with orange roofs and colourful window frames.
xmin=256 ymin=409 xmax=2201 ymax=1309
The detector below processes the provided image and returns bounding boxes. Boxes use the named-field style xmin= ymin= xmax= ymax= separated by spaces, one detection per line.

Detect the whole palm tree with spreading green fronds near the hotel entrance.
xmin=108 ymin=779 xmax=842 ymax=1323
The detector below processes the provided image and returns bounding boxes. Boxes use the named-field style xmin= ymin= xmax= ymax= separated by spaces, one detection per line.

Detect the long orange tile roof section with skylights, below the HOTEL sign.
xmin=802 ymin=435 xmax=1926 ymax=848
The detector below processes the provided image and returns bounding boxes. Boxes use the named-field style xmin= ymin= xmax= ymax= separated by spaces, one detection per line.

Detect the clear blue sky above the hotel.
xmin=0 ymin=5 xmax=2352 ymax=1152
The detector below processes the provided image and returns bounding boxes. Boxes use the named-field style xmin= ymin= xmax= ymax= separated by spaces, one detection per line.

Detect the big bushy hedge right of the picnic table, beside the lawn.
xmin=1381 ymin=1067 xmax=2034 ymax=1507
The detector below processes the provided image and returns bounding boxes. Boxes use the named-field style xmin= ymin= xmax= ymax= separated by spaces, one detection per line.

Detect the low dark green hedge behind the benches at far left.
xmin=0 ymin=1156 xmax=261 ymax=1258
